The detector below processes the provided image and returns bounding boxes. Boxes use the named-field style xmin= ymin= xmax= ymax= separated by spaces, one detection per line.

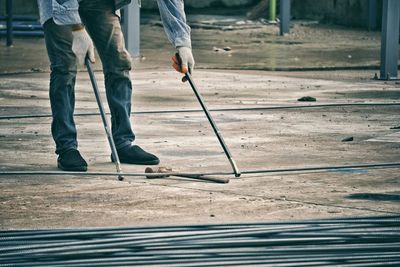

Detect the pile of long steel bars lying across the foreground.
xmin=0 ymin=216 xmax=400 ymax=267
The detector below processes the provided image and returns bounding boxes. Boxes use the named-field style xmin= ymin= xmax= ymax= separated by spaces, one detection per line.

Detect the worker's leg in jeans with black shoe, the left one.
xmin=44 ymin=19 xmax=87 ymax=170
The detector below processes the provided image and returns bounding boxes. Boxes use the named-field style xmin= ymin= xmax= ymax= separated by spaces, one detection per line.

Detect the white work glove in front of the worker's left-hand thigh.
xmin=72 ymin=28 xmax=96 ymax=65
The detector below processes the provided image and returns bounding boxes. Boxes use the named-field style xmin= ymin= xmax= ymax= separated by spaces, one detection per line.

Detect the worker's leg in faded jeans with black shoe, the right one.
xmin=79 ymin=0 xmax=159 ymax=164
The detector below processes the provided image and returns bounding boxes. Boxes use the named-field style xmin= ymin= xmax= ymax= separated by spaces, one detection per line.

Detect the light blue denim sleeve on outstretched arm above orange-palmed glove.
xmin=157 ymin=0 xmax=192 ymax=48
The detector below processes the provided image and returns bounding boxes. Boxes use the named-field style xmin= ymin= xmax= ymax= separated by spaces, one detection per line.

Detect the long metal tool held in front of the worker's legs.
xmin=85 ymin=58 xmax=124 ymax=181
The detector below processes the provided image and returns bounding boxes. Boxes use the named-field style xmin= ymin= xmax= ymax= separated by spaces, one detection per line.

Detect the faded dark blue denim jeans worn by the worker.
xmin=44 ymin=0 xmax=135 ymax=154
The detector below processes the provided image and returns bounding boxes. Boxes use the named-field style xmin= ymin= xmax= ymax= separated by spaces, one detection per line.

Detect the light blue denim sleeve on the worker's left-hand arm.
xmin=52 ymin=0 xmax=82 ymax=25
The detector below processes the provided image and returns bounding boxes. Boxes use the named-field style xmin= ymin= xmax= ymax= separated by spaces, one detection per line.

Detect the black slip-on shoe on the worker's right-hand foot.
xmin=111 ymin=145 xmax=160 ymax=165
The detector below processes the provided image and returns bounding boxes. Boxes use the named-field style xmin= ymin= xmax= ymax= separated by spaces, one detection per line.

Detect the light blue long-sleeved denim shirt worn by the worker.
xmin=37 ymin=0 xmax=191 ymax=48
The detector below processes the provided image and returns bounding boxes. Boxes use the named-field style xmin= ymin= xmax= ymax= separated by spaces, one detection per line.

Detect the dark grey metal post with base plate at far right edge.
xmin=380 ymin=0 xmax=400 ymax=80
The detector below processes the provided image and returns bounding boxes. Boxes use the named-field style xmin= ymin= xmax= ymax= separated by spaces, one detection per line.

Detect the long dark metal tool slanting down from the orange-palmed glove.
xmin=175 ymin=53 xmax=241 ymax=177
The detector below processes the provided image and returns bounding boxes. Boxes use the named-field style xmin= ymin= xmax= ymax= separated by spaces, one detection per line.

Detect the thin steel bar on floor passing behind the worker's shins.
xmin=0 ymin=102 xmax=400 ymax=120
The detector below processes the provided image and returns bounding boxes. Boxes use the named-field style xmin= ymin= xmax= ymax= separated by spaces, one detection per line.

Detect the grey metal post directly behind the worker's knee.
xmin=123 ymin=0 xmax=141 ymax=57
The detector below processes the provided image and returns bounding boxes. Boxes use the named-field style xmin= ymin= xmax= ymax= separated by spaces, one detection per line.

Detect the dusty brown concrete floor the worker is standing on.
xmin=0 ymin=18 xmax=400 ymax=229
